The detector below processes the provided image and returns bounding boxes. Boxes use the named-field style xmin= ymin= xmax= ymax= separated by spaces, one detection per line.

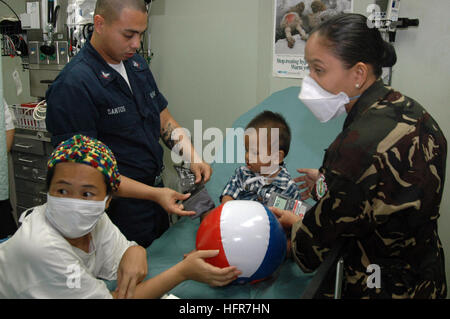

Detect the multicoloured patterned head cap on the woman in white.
xmin=47 ymin=135 xmax=120 ymax=191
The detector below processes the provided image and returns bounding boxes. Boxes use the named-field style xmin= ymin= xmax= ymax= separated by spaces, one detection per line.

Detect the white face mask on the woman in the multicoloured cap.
xmin=45 ymin=194 xmax=108 ymax=239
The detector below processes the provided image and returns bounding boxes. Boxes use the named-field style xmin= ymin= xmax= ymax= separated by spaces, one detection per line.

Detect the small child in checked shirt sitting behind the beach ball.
xmin=220 ymin=111 xmax=300 ymax=205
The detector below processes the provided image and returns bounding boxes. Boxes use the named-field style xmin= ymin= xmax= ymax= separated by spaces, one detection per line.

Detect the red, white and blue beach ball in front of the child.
xmin=196 ymin=200 xmax=286 ymax=284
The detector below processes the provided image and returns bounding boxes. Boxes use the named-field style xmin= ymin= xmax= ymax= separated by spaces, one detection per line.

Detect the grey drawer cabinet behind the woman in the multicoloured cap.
xmin=12 ymin=129 xmax=53 ymax=217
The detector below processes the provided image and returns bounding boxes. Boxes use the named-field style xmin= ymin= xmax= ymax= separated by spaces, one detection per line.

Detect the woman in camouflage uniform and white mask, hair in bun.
xmin=272 ymin=14 xmax=447 ymax=298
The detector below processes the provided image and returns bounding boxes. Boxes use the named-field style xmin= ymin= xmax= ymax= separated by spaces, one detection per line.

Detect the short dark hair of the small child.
xmin=245 ymin=110 xmax=291 ymax=157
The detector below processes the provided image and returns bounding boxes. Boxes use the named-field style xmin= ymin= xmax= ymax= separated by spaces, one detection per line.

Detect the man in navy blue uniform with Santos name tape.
xmin=46 ymin=0 xmax=212 ymax=247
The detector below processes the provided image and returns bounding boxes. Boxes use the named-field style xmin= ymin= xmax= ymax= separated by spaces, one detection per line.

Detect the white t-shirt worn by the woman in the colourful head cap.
xmin=0 ymin=204 xmax=136 ymax=299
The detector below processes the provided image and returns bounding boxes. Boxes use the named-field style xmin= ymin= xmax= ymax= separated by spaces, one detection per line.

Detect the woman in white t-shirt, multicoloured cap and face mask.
xmin=0 ymin=135 xmax=239 ymax=298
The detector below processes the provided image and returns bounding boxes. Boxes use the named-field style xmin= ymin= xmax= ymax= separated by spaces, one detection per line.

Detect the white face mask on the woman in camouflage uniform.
xmin=298 ymin=75 xmax=359 ymax=123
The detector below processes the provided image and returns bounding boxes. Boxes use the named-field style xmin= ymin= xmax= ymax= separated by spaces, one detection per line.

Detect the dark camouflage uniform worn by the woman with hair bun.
xmin=292 ymin=80 xmax=447 ymax=298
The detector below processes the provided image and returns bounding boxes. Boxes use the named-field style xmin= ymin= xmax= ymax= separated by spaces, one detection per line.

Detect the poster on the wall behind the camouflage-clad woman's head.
xmin=273 ymin=0 xmax=353 ymax=78
